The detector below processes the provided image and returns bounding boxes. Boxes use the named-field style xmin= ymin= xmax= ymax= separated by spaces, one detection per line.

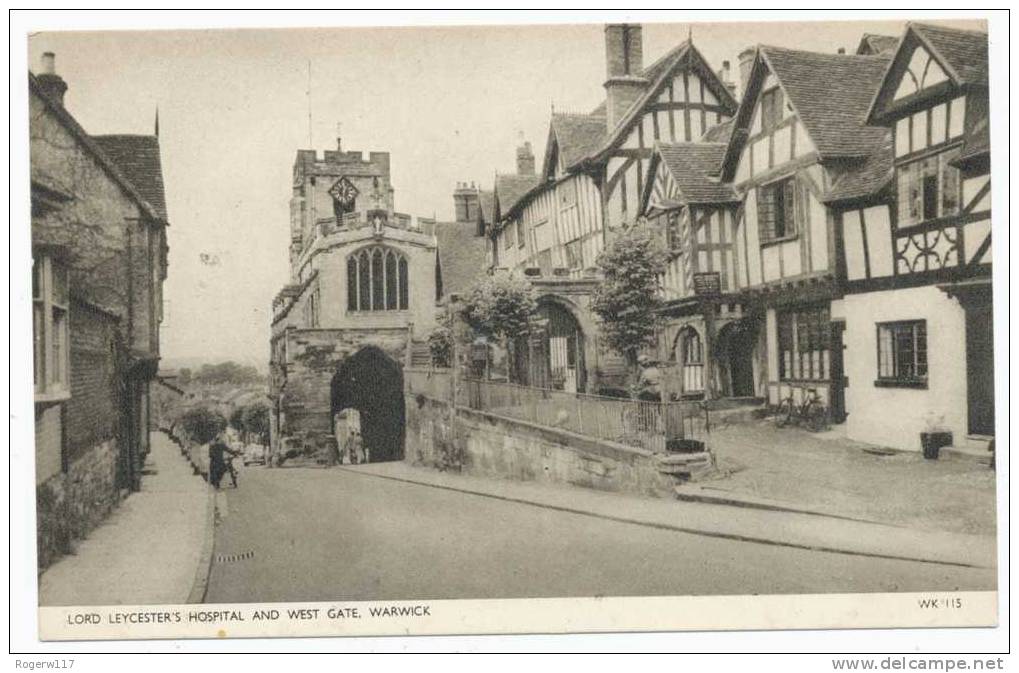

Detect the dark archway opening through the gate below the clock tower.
xmin=331 ymin=346 xmax=406 ymax=463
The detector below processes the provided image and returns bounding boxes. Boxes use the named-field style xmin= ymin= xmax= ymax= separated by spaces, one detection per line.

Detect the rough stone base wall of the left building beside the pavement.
xmin=36 ymin=439 xmax=120 ymax=571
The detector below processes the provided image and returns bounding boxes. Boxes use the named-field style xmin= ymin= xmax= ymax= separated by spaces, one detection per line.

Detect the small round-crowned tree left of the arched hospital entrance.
xmin=461 ymin=275 xmax=536 ymax=340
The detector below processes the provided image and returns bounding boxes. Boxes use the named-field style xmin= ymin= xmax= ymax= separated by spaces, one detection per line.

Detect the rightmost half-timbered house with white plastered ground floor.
xmin=829 ymin=23 xmax=995 ymax=450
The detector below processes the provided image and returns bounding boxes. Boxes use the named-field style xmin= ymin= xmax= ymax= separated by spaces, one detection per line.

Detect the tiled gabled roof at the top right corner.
xmin=867 ymin=23 xmax=987 ymax=121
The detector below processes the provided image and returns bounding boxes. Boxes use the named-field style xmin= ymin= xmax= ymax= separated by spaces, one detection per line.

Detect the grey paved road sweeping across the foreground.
xmin=206 ymin=468 xmax=995 ymax=603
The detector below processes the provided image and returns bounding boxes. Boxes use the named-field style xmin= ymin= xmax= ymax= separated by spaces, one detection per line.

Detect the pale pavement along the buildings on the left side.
xmin=39 ymin=432 xmax=213 ymax=606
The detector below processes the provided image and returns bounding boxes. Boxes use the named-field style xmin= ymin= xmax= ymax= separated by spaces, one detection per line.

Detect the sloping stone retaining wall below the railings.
xmin=405 ymin=396 xmax=675 ymax=496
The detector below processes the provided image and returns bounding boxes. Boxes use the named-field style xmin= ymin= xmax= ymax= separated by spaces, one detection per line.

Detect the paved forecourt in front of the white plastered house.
xmin=677 ymin=420 xmax=997 ymax=536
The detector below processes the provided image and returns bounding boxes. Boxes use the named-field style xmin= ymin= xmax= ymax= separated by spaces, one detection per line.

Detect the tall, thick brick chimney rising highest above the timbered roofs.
xmin=604 ymin=23 xmax=648 ymax=133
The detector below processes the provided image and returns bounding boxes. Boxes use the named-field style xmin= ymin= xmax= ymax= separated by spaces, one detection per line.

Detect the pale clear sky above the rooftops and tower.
xmin=29 ymin=14 xmax=985 ymax=369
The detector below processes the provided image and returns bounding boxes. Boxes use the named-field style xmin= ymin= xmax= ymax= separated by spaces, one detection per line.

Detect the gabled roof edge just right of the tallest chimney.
xmin=568 ymin=40 xmax=737 ymax=167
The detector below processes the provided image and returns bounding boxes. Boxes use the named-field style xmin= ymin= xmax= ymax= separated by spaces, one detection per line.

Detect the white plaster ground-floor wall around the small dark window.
xmin=844 ymin=287 xmax=967 ymax=451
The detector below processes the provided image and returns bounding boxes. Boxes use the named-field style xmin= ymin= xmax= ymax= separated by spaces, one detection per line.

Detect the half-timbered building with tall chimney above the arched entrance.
xmin=489 ymin=24 xmax=737 ymax=391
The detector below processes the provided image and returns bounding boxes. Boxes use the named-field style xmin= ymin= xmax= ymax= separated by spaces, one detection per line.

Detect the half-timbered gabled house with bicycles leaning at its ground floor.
xmin=696 ymin=46 xmax=891 ymax=420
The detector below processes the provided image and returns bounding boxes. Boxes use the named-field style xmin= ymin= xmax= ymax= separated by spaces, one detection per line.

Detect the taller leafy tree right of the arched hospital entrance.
xmin=591 ymin=225 xmax=665 ymax=373
